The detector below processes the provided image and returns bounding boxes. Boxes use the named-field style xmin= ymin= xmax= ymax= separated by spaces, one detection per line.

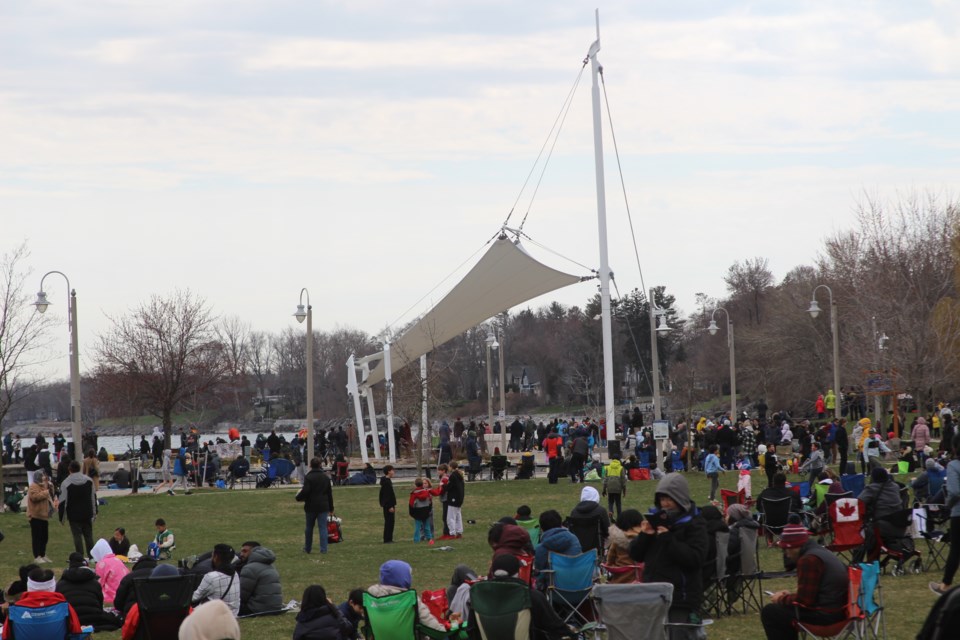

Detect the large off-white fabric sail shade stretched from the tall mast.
xmin=362 ymin=236 xmax=581 ymax=387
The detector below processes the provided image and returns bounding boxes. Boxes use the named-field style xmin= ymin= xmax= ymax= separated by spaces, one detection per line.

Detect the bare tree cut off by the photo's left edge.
xmin=0 ymin=244 xmax=49 ymax=492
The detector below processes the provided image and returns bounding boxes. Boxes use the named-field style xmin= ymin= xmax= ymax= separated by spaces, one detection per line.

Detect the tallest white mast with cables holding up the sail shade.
xmin=587 ymin=9 xmax=616 ymax=450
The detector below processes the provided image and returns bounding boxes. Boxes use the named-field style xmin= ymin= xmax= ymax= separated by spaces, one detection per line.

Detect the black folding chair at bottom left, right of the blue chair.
xmin=133 ymin=575 xmax=195 ymax=640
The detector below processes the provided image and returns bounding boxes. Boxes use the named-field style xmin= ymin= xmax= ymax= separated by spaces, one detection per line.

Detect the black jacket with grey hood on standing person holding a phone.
xmin=630 ymin=473 xmax=707 ymax=611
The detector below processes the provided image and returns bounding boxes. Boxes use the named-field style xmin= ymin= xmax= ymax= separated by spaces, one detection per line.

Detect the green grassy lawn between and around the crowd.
xmin=0 ymin=473 xmax=940 ymax=640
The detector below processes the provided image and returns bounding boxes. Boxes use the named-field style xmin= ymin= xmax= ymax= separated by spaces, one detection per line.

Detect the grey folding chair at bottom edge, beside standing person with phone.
xmin=593 ymin=582 xmax=673 ymax=640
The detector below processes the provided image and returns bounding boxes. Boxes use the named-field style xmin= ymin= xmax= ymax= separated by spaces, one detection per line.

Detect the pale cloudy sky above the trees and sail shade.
xmin=0 ymin=0 xmax=960 ymax=377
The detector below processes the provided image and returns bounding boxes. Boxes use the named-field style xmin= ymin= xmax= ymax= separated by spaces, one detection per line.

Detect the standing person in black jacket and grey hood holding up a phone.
xmin=630 ymin=473 xmax=709 ymax=640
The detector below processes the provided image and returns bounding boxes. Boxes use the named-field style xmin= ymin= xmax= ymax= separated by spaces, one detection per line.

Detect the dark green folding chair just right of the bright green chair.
xmin=470 ymin=580 xmax=531 ymax=640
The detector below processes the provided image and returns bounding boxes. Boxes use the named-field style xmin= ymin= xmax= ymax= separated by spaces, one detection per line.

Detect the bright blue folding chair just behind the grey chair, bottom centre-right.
xmin=541 ymin=549 xmax=597 ymax=627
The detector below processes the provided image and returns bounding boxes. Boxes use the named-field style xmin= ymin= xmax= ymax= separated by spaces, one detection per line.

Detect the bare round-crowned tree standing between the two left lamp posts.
xmin=96 ymin=290 xmax=230 ymax=447
